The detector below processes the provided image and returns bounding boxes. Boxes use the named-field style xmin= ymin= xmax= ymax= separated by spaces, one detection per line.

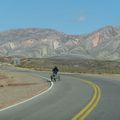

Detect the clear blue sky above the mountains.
xmin=0 ymin=0 xmax=120 ymax=35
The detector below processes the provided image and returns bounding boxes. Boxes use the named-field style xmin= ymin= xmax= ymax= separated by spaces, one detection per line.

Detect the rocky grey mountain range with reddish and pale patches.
xmin=0 ymin=26 xmax=120 ymax=60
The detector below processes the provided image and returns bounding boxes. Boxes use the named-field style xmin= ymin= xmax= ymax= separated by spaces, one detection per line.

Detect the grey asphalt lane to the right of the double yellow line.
xmin=77 ymin=75 xmax=120 ymax=120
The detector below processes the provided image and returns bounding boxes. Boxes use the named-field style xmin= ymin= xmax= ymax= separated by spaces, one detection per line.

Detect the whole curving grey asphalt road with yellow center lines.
xmin=0 ymin=70 xmax=120 ymax=120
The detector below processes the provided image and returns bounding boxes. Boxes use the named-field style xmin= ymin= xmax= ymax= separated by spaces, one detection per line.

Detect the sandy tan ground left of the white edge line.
xmin=0 ymin=65 xmax=50 ymax=109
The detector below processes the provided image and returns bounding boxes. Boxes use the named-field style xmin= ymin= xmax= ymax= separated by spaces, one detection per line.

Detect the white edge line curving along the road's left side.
xmin=0 ymin=76 xmax=54 ymax=112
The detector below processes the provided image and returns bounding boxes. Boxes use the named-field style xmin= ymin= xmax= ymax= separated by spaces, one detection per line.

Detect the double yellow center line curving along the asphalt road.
xmin=72 ymin=80 xmax=101 ymax=120
